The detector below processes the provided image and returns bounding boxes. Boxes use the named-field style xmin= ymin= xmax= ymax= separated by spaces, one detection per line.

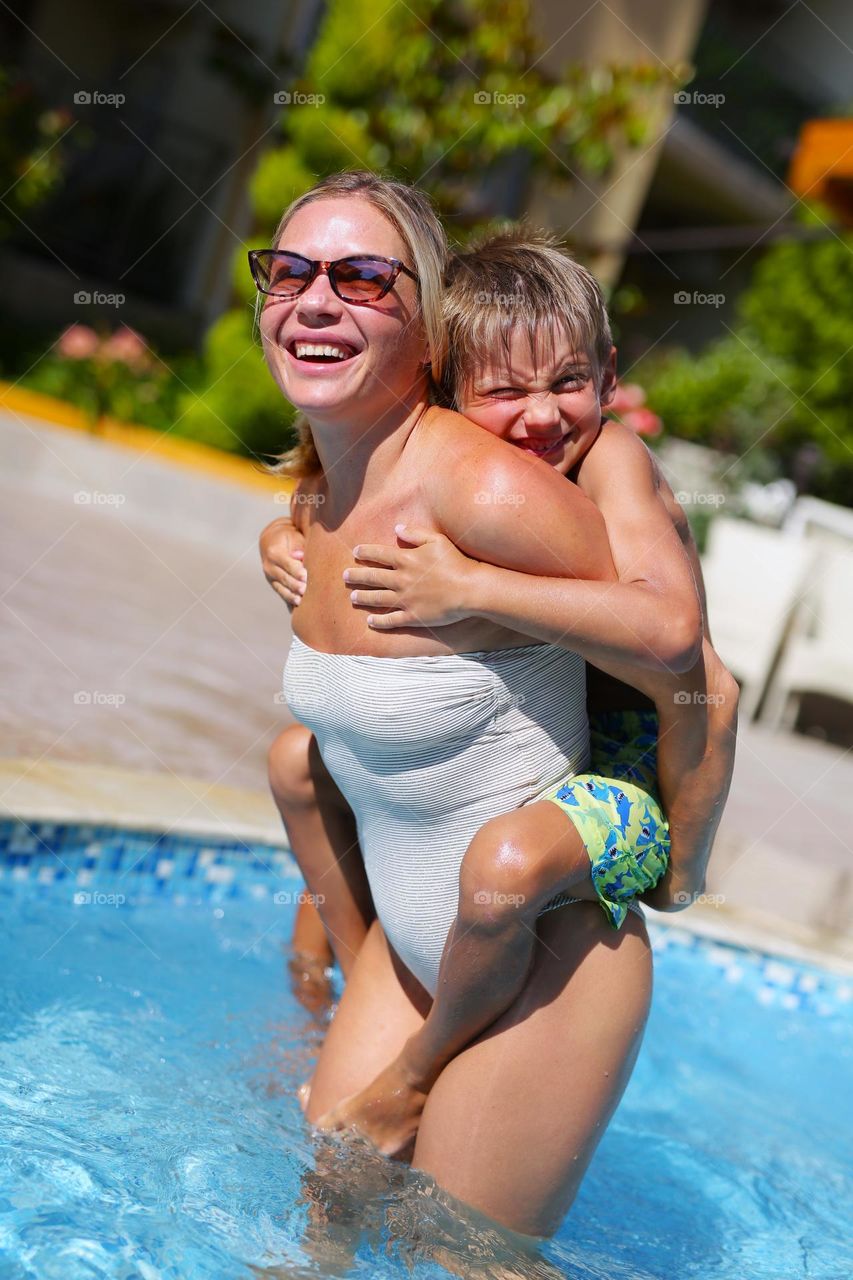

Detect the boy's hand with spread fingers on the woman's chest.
xmin=343 ymin=525 xmax=478 ymax=631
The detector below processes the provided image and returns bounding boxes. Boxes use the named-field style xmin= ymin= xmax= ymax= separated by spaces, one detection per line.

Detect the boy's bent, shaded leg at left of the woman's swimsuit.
xmin=268 ymin=724 xmax=375 ymax=978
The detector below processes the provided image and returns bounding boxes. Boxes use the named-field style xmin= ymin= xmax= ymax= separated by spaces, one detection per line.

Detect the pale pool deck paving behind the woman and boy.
xmin=0 ymin=404 xmax=853 ymax=972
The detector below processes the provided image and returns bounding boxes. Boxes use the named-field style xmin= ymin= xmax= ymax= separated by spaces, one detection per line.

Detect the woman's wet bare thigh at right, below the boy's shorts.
xmin=412 ymin=902 xmax=652 ymax=1235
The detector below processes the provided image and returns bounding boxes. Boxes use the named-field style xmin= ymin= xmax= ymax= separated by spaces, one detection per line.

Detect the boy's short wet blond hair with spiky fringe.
xmin=441 ymin=227 xmax=612 ymax=404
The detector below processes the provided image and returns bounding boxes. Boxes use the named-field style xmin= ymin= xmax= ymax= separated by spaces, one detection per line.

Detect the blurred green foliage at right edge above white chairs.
xmin=638 ymin=211 xmax=853 ymax=506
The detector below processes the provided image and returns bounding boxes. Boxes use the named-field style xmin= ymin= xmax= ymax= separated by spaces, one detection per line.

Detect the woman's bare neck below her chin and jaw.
xmin=309 ymin=393 xmax=429 ymax=515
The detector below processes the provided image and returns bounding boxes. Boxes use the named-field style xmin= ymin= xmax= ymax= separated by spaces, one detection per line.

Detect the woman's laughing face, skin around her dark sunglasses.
xmin=253 ymin=196 xmax=428 ymax=421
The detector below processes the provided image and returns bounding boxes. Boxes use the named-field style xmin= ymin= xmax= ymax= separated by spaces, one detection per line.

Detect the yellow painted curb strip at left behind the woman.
xmin=0 ymin=381 xmax=293 ymax=493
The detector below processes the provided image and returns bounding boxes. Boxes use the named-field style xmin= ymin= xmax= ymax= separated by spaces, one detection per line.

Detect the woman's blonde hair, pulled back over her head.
xmin=268 ymin=169 xmax=448 ymax=479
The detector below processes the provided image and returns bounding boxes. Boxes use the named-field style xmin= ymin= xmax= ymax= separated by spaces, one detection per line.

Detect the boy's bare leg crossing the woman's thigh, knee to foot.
xmin=308 ymin=800 xmax=597 ymax=1155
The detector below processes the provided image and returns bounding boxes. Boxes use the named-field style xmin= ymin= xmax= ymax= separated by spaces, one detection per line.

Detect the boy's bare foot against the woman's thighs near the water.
xmin=316 ymin=1062 xmax=428 ymax=1156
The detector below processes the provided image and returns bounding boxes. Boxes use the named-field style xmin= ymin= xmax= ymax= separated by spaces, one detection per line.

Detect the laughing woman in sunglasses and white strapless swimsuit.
xmin=252 ymin=174 xmax=651 ymax=1235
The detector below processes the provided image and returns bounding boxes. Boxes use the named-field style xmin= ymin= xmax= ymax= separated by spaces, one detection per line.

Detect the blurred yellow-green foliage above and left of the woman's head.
xmin=181 ymin=0 xmax=670 ymax=452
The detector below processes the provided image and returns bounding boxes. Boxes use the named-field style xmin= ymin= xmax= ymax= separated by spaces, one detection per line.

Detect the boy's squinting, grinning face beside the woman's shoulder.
xmin=459 ymin=330 xmax=616 ymax=475
